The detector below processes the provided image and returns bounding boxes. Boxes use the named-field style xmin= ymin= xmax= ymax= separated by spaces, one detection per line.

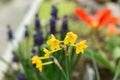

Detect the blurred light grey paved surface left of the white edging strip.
xmin=0 ymin=0 xmax=32 ymax=54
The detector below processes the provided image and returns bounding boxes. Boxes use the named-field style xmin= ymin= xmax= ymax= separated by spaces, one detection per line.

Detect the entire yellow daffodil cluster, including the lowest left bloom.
xmin=32 ymin=32 xmax=88 ymax=72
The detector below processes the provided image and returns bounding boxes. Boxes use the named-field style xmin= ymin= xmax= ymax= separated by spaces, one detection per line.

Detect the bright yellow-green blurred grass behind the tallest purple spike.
xmin=38 ymin=0 xmax=76 ymax=19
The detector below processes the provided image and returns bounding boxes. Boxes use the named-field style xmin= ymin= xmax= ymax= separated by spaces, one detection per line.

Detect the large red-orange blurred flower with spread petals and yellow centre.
xmin=75 ymin=8 xmax=118 ymax=29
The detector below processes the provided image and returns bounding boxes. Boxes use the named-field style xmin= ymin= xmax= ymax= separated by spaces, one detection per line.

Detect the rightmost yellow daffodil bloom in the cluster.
xmin=75 ymin=40 xmax=88 ymax=54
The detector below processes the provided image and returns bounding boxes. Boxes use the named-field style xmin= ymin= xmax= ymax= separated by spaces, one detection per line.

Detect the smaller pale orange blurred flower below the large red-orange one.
xmin=106 ymin=24 xmax=118 ymax=36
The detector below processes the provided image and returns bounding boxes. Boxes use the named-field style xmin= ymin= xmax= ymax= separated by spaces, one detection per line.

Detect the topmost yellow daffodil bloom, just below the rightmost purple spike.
xmin=64 ymin=32 xmax=78 ymax=45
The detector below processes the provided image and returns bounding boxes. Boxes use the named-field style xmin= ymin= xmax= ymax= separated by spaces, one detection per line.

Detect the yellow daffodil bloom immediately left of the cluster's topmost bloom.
xmin=47 ymin=35 xmax=60 ymax=50
